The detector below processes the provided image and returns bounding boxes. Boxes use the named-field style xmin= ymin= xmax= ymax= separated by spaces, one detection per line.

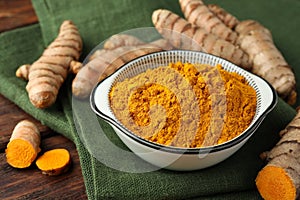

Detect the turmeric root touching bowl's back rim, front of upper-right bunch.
xmin=152 ymin=9 xmax=252 ymax=70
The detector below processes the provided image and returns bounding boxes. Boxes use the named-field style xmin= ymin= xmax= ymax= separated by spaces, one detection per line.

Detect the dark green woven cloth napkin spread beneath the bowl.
xmin=0 ymin=0 xmax=300 ymax=199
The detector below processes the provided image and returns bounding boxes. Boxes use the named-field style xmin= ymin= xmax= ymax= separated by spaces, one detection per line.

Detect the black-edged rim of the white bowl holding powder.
xmin=90 ymin=49 xmax=278 ymax=154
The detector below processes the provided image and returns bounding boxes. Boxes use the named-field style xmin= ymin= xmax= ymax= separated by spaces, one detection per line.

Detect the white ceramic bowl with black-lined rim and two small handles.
xmin=90 ymin=50 xmax=277 ymax=171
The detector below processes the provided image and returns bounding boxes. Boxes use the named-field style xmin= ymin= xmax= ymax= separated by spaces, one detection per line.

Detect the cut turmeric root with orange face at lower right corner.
xmin=256 ymin=109 xmax=300 ymax=200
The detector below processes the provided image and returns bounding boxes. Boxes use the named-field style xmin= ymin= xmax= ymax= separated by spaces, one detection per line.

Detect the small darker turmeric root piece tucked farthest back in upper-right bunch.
xmin=207 ymin=4 xmax=240 ymax=30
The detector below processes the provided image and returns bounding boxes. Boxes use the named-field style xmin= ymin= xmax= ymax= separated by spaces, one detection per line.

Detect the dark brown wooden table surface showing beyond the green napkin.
xmin=0 ymin=0 xmax=87 ymax=200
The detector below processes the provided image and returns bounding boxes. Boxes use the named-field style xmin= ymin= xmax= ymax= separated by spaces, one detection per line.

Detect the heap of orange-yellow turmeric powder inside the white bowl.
xmin=109 ymin=62 xmax=256 ymax=148
